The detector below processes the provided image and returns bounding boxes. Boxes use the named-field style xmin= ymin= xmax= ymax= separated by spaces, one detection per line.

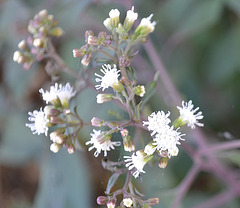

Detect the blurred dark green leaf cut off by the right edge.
xmin=207 ymin=27 xmax=240 ymax=83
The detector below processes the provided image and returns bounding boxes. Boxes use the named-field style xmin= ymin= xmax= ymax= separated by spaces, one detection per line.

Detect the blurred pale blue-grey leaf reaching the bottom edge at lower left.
xmin=34 ymin=149 xmax=91 ymax=208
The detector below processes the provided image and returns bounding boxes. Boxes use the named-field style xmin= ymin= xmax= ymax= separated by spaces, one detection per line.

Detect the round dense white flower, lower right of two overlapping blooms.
xmin=153 ymin=126 xmax=184 ymax=157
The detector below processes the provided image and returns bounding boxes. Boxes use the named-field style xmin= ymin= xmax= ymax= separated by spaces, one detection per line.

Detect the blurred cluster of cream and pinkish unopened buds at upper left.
xmin=13 ymin=10 xmax=63 ymax=70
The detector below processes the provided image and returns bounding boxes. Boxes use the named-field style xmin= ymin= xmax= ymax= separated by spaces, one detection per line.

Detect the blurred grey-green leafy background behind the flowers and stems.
xmin=0 ymin=0 xmax=240 ymax=208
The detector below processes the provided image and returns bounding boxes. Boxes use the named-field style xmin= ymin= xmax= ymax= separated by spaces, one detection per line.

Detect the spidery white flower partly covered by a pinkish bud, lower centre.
xmin=86 ymin=129 xmax=121 ymax=157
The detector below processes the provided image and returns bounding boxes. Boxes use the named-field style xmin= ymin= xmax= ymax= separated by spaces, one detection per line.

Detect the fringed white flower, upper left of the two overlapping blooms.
xmin=143 ymin=111 xmax=171 ymax=136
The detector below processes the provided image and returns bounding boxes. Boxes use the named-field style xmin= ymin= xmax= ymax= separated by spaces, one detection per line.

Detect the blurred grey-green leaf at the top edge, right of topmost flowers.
xmin=177 ymin=0 xmax=223 ymax=35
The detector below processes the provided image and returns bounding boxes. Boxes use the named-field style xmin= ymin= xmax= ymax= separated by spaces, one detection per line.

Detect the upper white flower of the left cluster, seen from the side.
xmin=39 ymin=83 xmax=76 ymax=107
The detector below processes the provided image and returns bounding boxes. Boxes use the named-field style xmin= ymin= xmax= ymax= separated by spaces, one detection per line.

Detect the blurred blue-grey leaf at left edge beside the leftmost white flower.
xmin=0 ymin=112 xmax=44 ymax=166
